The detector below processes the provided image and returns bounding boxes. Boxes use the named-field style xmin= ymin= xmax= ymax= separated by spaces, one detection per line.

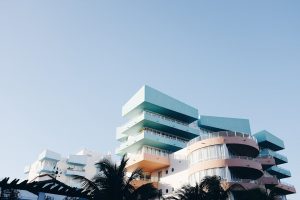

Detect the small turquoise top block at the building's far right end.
xmin=254 ymin=130 xmax=284 ymax=151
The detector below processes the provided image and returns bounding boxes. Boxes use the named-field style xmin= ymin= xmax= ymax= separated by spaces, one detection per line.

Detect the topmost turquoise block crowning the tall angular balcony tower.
xmin=122 ymin=85 xmax=198 ymax=123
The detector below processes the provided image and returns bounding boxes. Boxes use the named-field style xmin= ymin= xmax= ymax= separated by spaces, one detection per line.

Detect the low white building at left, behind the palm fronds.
xmin=24 ymin=149 xmax=111 ymax=188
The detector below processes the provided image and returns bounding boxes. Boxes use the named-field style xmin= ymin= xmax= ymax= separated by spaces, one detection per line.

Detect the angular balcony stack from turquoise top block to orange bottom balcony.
xmin=116 ymin=86 xmax=199 ymax=172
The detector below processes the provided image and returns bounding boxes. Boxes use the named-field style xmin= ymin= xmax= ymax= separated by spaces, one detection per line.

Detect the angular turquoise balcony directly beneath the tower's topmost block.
xmin=117 ymin=111 xmax=199 ymax=140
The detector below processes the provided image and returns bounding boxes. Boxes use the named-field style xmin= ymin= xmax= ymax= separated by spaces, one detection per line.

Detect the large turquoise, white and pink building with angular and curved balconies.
xmin=116 ymin=86 xmax=296 ymax=199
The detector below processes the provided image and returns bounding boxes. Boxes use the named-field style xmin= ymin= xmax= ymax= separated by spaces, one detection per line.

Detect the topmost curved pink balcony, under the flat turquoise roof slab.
xmin=188 ymin=131 xmax=259 ymax=157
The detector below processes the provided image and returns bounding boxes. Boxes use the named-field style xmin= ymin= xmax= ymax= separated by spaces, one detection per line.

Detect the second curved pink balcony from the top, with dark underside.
xmin=188 ymin=156 xmax=263 ymax=179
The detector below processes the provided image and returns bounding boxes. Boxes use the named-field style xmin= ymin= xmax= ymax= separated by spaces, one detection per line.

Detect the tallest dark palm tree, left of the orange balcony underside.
xmin=74 ymin=155 xmax=158 ymax=200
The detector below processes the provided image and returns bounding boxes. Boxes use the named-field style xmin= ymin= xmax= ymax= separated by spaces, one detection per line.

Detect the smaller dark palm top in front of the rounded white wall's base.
xmin=167 ymin=176 xmax=228 ymax=200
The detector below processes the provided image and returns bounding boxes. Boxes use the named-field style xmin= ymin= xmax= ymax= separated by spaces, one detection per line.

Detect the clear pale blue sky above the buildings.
xmin=0 ymin=0 xmax=300 ymax=200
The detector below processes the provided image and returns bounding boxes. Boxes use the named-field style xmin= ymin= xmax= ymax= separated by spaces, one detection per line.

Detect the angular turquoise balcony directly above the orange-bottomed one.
xmin=116 ymin=129 xmax=187 ymax=155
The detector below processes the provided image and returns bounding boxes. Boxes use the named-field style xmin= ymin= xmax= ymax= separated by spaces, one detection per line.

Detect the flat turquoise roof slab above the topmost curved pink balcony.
xmin=198 ymin=115 xmax=251 ymax=134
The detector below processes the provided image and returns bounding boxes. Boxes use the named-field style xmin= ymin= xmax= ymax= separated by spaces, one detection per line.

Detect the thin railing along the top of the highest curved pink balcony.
xmin=188 ymin=131 xmax=257 ymax=145
